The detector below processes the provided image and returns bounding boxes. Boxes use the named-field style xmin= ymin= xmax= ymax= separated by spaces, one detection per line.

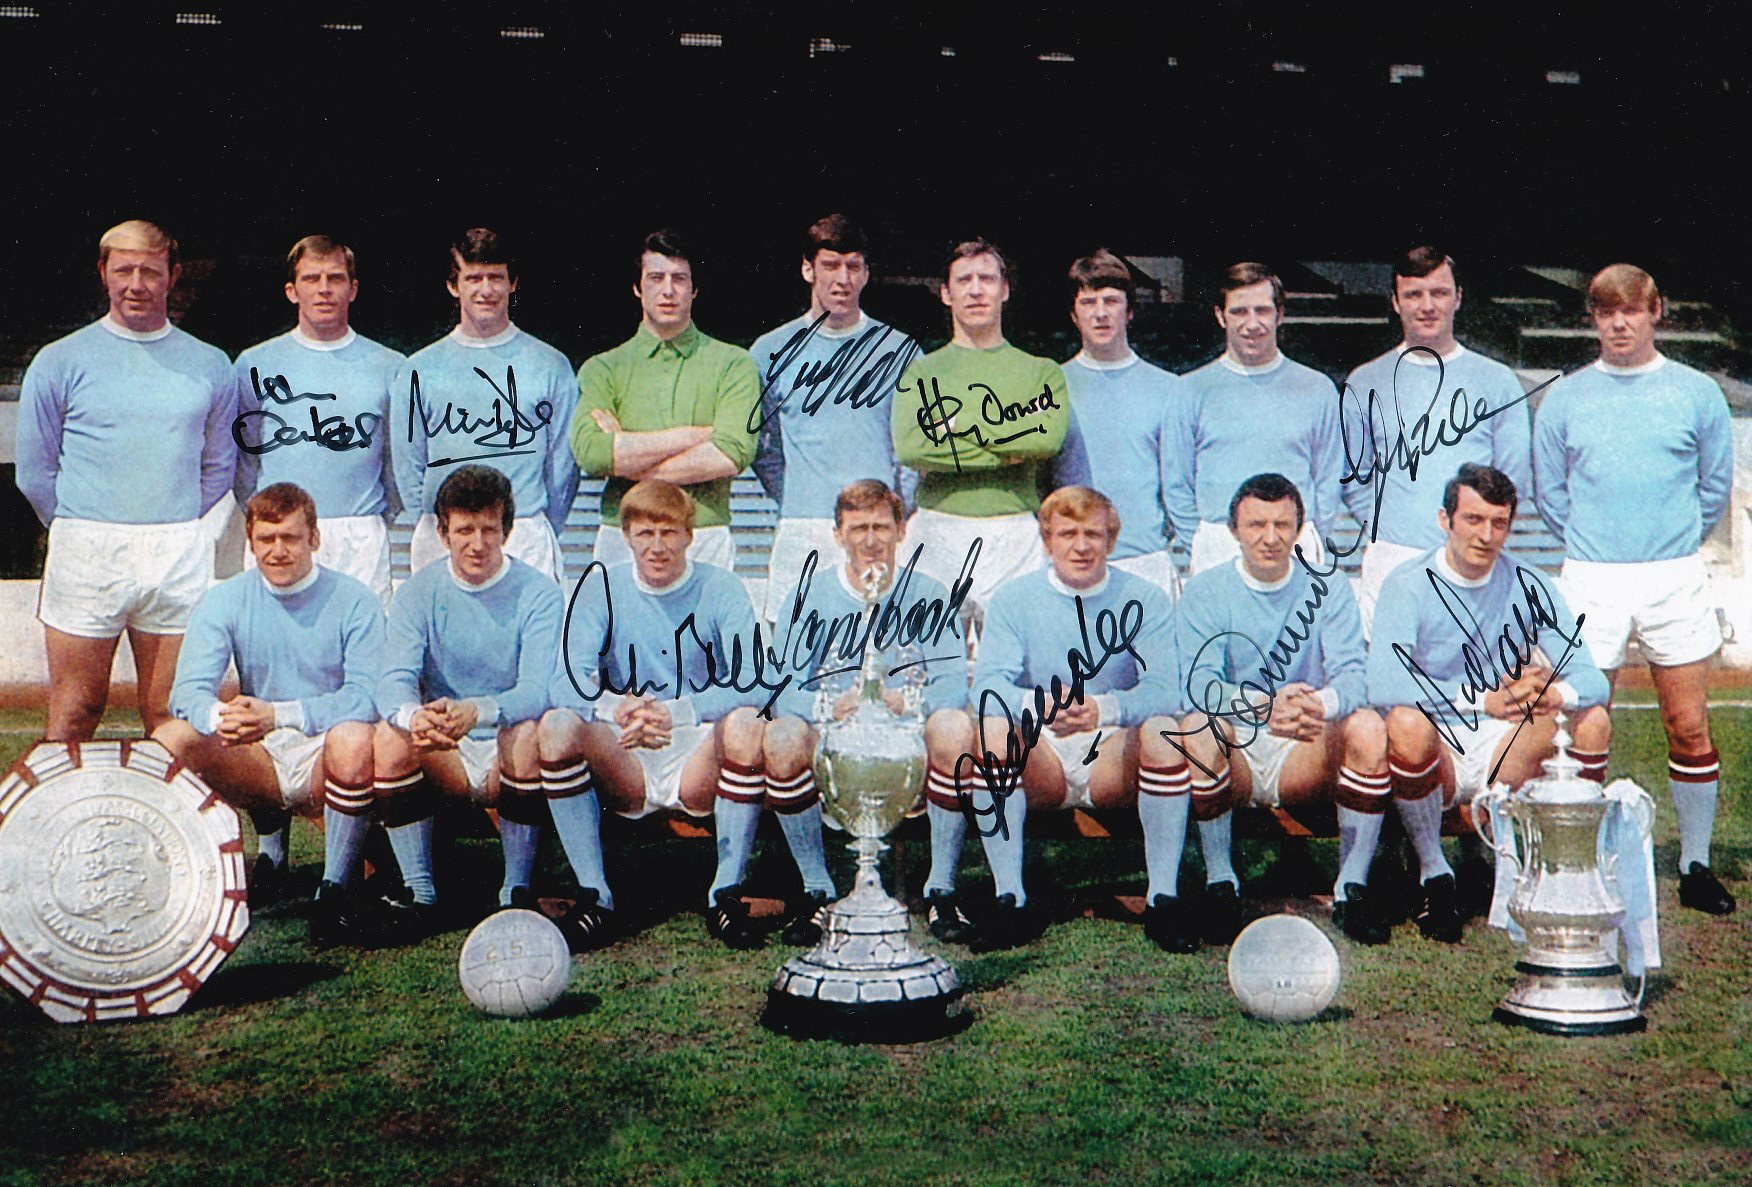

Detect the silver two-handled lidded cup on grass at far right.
xmin=1473 ymin=716 xmax=1654 ymax=1035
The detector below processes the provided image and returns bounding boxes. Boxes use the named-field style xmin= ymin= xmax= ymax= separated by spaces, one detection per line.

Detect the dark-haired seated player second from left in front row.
xmin=373 ymin=466 xmax=564 ymax=938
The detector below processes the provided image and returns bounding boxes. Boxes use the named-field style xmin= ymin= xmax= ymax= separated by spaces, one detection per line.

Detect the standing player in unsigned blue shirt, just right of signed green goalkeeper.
xmin=1053 ymin=249 xmax=1181 ymax=599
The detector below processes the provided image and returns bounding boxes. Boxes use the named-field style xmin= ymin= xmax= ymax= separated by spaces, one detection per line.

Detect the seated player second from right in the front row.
xmin=1174 ymin=474 xmax=1389 ymax=944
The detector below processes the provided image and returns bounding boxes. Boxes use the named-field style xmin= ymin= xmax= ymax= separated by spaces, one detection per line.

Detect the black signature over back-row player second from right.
xmin=1339 ymin=347 xmax=1558 ymax=539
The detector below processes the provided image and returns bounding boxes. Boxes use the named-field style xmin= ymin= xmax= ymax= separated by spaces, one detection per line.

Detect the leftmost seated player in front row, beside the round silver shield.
xmin=152 ymin=481 xmax=384 ymax=942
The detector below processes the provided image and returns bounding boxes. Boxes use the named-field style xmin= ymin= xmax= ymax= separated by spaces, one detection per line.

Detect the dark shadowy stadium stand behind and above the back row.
xmin=0 ymin=0 xmax=1748 ymax=576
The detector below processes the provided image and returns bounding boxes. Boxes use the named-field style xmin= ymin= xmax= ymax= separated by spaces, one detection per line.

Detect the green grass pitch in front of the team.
xmin=0 ymin=709 xmax=1752 ymax=1187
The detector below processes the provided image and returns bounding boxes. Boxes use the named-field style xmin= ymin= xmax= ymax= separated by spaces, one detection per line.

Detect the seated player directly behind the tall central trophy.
xmin=766 ymin=478 xmax=974 ymax=944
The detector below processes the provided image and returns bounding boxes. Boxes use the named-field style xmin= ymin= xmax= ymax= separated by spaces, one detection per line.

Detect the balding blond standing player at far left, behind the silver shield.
xmin=18 ymin=219 xmax=237 ymax=742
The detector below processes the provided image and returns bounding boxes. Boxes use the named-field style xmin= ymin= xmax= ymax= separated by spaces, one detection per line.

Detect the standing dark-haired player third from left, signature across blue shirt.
xmin=389 ymin=228 xmax=578 ymax=581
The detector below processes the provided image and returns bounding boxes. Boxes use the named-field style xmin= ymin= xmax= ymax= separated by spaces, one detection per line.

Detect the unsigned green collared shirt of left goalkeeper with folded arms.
xmin=571 ymin=322 xmax=760 ymax=527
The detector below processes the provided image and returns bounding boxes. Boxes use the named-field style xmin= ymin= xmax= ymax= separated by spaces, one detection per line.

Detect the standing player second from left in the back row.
xmin=231 ymin=235 xmax=406 ymax=606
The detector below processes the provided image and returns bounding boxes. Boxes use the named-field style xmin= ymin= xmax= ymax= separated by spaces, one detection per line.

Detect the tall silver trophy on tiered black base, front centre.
xmin=764 ymin=567 xmax=962 ymax=1042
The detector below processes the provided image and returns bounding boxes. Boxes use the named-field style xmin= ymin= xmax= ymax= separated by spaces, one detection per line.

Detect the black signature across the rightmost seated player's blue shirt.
xmin=1393 ymin=565 xmax=1587 ymax=781
